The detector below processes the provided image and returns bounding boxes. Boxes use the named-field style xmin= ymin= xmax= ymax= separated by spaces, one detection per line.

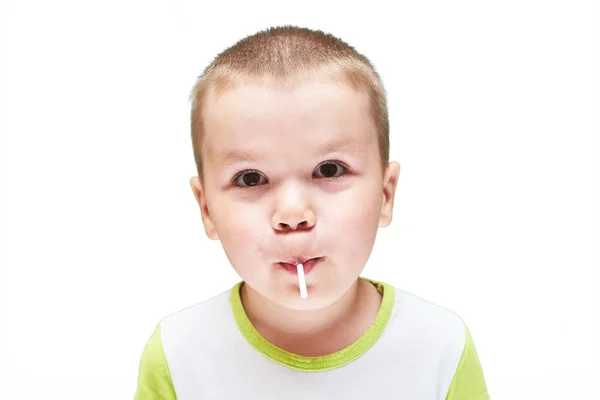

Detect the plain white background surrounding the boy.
xmin=0 ymin=0 xmax=600 ymax=400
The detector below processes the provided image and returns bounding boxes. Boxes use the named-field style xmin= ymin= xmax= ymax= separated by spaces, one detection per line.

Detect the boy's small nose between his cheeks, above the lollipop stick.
xmin=271 ymin=187 xmax=317 ymax=232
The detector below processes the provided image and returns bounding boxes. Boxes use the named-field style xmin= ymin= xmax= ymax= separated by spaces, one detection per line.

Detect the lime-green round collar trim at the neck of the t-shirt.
xmin=230 ymin=278 xmax=395 ymax=372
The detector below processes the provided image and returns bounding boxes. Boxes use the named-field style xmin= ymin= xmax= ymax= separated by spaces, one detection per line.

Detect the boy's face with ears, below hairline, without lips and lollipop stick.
xmin=191 ymin=79 xmax=400 ymax=309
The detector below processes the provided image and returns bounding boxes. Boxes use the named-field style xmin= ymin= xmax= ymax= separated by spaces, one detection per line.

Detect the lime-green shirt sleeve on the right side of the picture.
xmin=446 ymin=326 xmax=490 ymax=400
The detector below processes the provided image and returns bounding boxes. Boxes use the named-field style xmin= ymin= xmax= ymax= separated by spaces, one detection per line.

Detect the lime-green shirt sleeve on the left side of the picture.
xmin=134 ymin=323 xmax=177 ymax=400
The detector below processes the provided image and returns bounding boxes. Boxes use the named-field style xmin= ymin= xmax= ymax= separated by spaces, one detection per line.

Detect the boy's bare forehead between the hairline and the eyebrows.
xmin=203 ymin=78 xmax=377 ymax=163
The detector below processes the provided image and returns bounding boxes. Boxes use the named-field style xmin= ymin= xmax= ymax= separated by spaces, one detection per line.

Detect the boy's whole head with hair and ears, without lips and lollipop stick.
xmin=191 ymin=27 xmax=400 ymax=309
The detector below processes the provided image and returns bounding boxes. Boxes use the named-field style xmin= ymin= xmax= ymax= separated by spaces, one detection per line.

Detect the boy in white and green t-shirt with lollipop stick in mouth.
xmin=135 ymin=27 xmax=489 ymax=400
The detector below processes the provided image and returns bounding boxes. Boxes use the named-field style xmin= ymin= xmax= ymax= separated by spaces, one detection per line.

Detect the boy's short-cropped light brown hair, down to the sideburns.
xmin=190 ymin=26 xmax=390 ymax=180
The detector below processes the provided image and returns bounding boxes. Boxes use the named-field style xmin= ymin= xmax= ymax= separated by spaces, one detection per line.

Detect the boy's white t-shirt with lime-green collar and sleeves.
xmin=135 ymin=278 xmax=489 ymax=400
